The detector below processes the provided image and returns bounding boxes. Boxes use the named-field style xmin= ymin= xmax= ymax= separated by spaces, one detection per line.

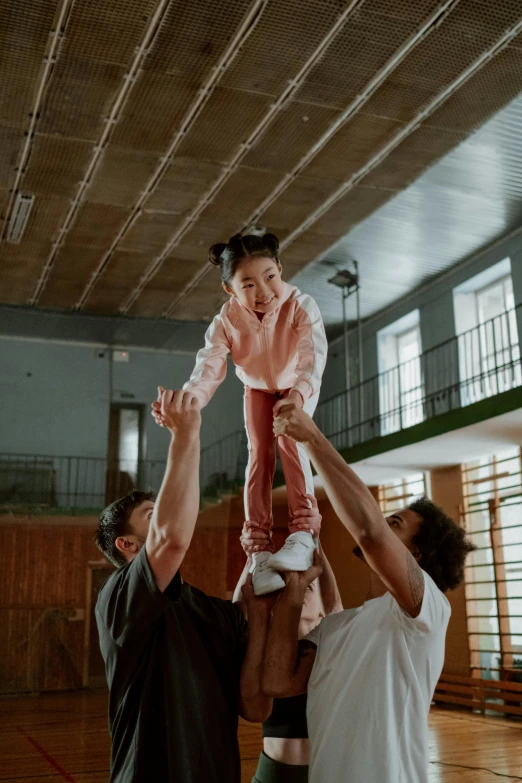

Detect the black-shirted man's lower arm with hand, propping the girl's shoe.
xmin=239 ymin=574 xmax=278 ymax=723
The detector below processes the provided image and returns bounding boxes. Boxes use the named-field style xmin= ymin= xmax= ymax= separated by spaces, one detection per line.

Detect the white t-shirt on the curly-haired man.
xmin=306 ymin=572 xmax=451 ymax=783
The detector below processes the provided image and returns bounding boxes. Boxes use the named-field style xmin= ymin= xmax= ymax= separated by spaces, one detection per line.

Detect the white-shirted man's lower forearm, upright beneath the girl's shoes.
xmin=261 ymin=587 xmax=304 ymax=696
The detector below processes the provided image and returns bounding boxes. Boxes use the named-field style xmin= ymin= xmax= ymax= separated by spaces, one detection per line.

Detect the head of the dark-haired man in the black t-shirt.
xmin=94 ymin=489 xmax=154 ymax=567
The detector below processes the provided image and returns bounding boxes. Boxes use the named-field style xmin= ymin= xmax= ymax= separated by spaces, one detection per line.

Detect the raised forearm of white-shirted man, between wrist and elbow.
xmin=304 ymin=425 xmax=384 ymax=542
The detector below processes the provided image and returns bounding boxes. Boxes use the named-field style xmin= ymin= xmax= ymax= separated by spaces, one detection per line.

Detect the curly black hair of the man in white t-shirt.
xmin=407 ymin=497 xmax=476 ymax=593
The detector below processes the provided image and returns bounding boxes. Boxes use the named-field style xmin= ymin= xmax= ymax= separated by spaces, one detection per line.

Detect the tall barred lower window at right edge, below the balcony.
xmin=463 ymin=448 xmax=522 ymax=682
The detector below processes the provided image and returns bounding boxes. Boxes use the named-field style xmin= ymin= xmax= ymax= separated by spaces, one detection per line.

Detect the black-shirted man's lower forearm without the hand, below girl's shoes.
xmin=240 ymin=608 xmax=272 ymax=723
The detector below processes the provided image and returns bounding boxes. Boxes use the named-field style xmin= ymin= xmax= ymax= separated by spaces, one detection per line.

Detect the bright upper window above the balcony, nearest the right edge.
xmin=454 ymin=258 xmax=522 ymax=405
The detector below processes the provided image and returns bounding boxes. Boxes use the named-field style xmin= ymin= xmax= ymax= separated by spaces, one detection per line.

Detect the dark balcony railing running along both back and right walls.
xmin=0 ymin=306 xmax=522 ymax=511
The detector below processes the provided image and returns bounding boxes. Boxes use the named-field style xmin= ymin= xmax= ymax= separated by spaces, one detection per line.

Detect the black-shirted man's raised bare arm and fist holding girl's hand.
xmin=145 ymin=390 xmax=201 ymax=591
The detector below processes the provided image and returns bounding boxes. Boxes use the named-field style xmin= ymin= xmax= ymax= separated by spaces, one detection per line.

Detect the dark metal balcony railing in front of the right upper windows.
xmin=314 ymin=305 xmax=522 ymax=450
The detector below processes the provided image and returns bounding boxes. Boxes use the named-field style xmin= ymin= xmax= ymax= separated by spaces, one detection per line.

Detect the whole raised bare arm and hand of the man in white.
xmin=274 ymin=405 xmax=424 ymax=617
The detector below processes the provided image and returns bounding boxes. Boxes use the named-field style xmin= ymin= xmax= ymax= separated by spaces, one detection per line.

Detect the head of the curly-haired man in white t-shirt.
xmin=354 ymin=497 xmax=475 ymax=593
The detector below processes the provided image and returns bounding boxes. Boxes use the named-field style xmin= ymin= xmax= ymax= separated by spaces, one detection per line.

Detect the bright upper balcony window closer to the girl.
xmin=377 ymin=310 xmax=424 ymax=435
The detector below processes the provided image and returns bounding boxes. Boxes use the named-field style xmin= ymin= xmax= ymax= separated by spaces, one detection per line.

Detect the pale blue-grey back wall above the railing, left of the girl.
xmin=0 ymin=336 xmax=243 ymax=459
